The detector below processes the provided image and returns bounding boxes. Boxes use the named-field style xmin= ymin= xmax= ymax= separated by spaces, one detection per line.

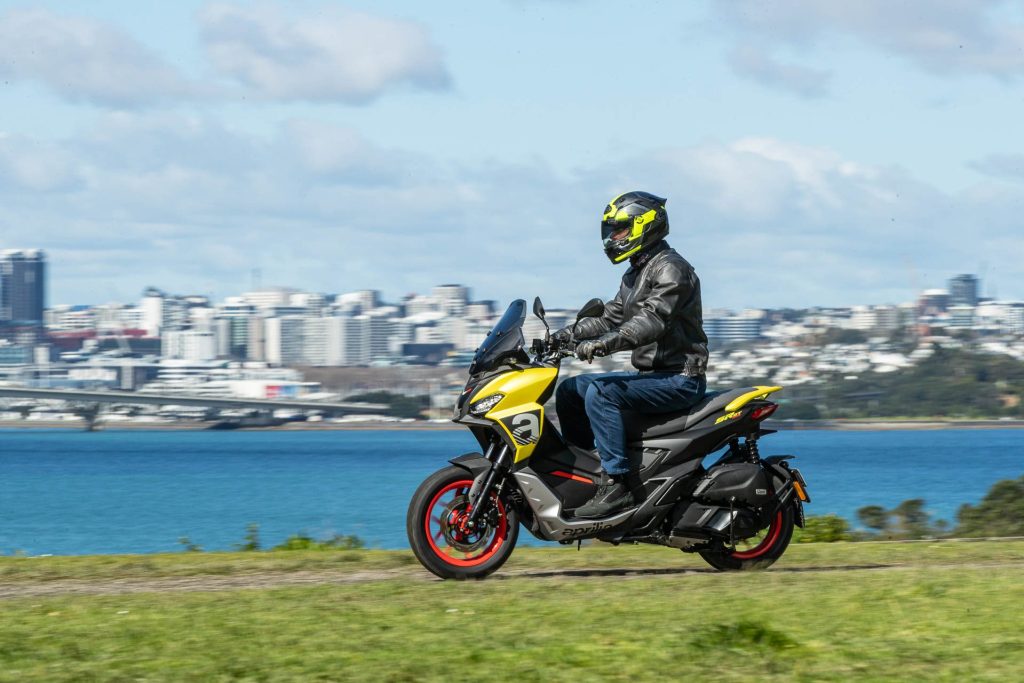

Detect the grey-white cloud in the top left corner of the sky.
xmin=0 ymin=9 xmax=199 ymax=108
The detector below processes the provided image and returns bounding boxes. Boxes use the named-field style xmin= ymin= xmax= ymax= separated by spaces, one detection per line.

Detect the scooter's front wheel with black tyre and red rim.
xmin=406 ymin=465 xmax=519 ymax=579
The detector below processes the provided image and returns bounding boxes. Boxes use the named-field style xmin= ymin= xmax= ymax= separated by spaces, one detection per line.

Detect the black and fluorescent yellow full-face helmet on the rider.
xmin=601 ymin=190 xmax=669 ymax=263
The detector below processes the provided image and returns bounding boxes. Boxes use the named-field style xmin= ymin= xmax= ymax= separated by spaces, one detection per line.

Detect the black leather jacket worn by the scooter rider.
xmin=577 ymin=240 xmax=708 ymax=377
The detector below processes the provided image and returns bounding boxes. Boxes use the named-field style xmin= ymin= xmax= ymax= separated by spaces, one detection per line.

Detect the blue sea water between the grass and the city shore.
xmin=0 ymin=429 xmax=1024 ymax=555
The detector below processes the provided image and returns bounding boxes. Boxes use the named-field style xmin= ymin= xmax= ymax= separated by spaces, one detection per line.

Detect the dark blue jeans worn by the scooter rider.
xmin=555 ymin=373 xmax=708 ymax=474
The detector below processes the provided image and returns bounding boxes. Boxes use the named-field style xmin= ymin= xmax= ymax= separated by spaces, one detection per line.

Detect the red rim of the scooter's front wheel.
xmin=424 ymin=479 xmax=508 ymax=567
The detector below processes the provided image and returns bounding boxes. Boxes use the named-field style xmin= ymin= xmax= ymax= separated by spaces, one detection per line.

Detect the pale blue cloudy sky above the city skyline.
xmin=0 ymin=0 xmax=1024 ymax=309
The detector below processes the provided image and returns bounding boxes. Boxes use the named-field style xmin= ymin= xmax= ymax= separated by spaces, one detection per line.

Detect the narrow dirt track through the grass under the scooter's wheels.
xmin=0 ymin=561 xmax=1024 ymax=600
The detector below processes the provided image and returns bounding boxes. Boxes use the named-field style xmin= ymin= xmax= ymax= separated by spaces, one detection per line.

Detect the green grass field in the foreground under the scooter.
xmin=0 ymin=542 xmax=1024 ymax=681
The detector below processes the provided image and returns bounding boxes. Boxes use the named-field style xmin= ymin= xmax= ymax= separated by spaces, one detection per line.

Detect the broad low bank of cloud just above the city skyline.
xmin=0 ymin=113 xmax=1024 ymax=307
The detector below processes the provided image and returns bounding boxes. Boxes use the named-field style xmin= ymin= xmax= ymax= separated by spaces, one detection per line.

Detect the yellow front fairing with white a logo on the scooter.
xmin=473 ymin=368 xmax=558 ymax=463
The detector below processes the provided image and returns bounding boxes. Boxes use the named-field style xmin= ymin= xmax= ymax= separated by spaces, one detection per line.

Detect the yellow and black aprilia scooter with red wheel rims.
xmin=407 ymin=298 xmax=810 ymax=579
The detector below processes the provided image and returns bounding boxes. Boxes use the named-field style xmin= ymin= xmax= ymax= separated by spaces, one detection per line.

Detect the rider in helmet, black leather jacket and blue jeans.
xmin=554 ymin=191 xmax=708 ymax=519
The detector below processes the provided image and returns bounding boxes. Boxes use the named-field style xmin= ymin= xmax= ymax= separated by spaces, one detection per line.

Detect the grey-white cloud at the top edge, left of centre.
xmin=200 ymin=3 xmax=450 ymax=103
